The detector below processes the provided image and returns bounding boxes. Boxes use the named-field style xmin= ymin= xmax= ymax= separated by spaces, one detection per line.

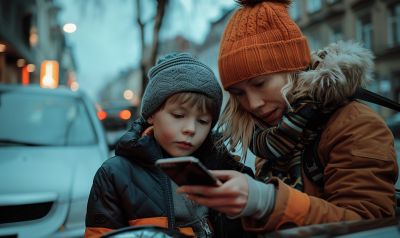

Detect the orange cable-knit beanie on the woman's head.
xmin=218 ymin=0 xmax=311 ymax=89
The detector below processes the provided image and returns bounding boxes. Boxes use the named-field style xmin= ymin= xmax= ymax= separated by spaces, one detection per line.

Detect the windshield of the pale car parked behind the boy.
xmin=0 ymin=91 xmax=96 ymax=146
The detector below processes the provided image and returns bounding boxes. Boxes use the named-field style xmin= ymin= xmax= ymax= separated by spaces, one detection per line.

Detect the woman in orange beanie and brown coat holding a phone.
xmin=178 ymin=0 xmax=397 ymax=232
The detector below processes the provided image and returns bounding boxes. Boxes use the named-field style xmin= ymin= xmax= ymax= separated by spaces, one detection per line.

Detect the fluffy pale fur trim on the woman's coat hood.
xmin=293 ymin=41 xmax=374 ymax=108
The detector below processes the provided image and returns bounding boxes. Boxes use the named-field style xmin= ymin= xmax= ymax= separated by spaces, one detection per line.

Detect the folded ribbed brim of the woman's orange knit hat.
xmin=218 ymin=37 xmax=311 ymax=89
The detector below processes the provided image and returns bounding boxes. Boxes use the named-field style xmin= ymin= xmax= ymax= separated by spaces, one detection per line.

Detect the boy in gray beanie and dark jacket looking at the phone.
xmin=85 ymin=53 xmax=255 ymax=237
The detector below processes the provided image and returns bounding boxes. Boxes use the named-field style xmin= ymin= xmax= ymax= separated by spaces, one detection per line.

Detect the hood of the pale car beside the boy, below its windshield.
xmin=0 ymin=146 xmax=106 ymax=205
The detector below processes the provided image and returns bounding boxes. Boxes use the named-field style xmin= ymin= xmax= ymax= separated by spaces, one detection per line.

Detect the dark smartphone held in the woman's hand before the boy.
xmin=156 ymin=156 xmax=222 ymax=186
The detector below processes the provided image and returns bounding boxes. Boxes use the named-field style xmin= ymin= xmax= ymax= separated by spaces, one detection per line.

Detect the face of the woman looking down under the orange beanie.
xmin=228 ymin=73 xmax=288 ymax=125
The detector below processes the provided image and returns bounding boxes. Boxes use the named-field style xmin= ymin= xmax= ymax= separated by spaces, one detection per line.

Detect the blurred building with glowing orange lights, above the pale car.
xmin=0 ymin=0 xmax=76 ymax=85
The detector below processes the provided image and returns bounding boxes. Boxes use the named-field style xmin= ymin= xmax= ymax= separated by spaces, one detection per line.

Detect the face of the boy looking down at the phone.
xmin=148 ymin=100 xmax=212 ymax=157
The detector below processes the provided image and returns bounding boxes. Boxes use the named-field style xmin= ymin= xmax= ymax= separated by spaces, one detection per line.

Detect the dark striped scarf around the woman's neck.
xmin=251 ymin=99 xmax=329 ymax=191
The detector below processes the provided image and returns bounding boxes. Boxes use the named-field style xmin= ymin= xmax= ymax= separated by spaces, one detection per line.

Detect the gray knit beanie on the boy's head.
xmin=141 ymin=53 xmax=222 ymax=126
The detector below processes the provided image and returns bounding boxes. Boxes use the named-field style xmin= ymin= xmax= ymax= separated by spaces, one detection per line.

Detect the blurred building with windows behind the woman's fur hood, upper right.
xmin=290 ymin=0 xmax=400 ymax=117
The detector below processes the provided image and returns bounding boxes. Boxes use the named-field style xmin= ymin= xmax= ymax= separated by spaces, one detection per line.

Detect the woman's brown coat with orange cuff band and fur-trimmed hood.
xmin=243 ymin=43 xmax=398 ymax=231
